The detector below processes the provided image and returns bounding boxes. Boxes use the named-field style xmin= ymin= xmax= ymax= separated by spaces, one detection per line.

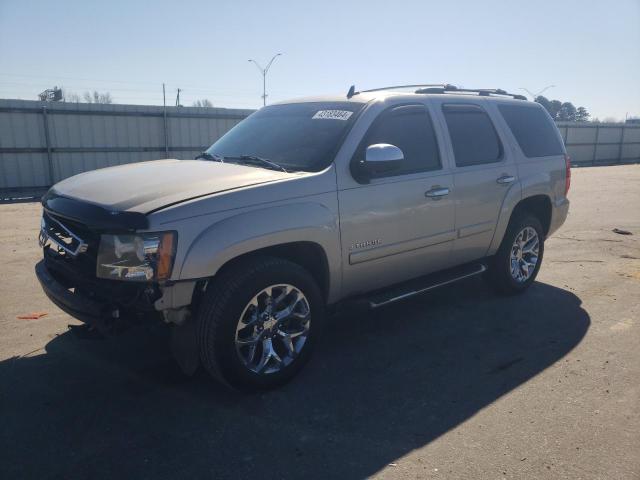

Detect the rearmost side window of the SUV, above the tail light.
xmin=498 ymin=105 xmax=564 ymax=157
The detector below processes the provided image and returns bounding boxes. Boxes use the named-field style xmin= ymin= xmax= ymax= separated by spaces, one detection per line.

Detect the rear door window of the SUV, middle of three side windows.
xmin=442 ymin=104 xmax=502 ymax=167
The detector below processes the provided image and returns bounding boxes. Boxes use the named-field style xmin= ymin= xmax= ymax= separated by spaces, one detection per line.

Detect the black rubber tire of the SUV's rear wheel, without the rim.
xmin=488 ymin=212 xmax=544 ymax=295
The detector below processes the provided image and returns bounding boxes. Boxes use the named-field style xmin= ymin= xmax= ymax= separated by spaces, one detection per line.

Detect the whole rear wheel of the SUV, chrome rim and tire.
xmin=488 ymin=214 xmax=544 ymax=295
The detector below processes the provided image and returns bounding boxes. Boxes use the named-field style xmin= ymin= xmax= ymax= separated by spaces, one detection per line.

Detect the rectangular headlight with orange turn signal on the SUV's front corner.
xmin=96 ymin=232 xmax=176 ymax=282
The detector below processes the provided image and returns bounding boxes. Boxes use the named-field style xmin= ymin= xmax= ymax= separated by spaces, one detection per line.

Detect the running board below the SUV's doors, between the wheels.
xmin=367 ymin=263 xmax=487 ymax=308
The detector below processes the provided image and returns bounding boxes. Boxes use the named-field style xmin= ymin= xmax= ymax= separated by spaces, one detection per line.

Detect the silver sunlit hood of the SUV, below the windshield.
xmin=52 ymin=160 xmax=296 ymax=214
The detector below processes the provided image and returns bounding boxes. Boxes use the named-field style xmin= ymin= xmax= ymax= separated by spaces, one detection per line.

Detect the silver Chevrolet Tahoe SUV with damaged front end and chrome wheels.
xmin=36 ymin=85 xmax=570 ymax=390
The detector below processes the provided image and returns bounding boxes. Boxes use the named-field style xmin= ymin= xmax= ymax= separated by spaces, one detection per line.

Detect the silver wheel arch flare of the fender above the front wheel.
xmin=180 ymin=202 xmax=342 ymax=301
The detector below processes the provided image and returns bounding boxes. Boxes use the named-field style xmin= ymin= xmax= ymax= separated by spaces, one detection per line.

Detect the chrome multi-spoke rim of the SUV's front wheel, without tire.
xmin=235 ymin=284 xmax=311 ymax=375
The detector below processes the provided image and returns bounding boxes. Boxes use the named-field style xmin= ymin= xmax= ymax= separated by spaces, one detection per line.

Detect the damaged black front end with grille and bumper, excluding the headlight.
xmin=35 ymin=195 xmax=197 ymax=333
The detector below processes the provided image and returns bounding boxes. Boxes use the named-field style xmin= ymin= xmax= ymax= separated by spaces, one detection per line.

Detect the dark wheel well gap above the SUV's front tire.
xmin=212 ymin=242 xmax=329 ymax=301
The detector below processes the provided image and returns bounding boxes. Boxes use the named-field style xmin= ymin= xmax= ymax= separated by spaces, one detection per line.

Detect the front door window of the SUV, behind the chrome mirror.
xmin=357 ymin=105 xmax=440 ymax=177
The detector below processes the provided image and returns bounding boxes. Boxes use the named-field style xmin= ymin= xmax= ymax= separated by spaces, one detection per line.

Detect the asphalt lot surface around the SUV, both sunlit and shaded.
xmin=0 ymin=165 xmax=640 ymax=479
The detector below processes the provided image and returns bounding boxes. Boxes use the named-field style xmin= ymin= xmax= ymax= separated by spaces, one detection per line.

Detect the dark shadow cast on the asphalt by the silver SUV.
xmin=0 ymin=279 xmax=590 ymax=479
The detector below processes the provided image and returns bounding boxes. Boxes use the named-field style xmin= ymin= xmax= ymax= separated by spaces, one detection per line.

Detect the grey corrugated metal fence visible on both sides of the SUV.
xmin=0 ymin=100 xmax=640 ymax=190
